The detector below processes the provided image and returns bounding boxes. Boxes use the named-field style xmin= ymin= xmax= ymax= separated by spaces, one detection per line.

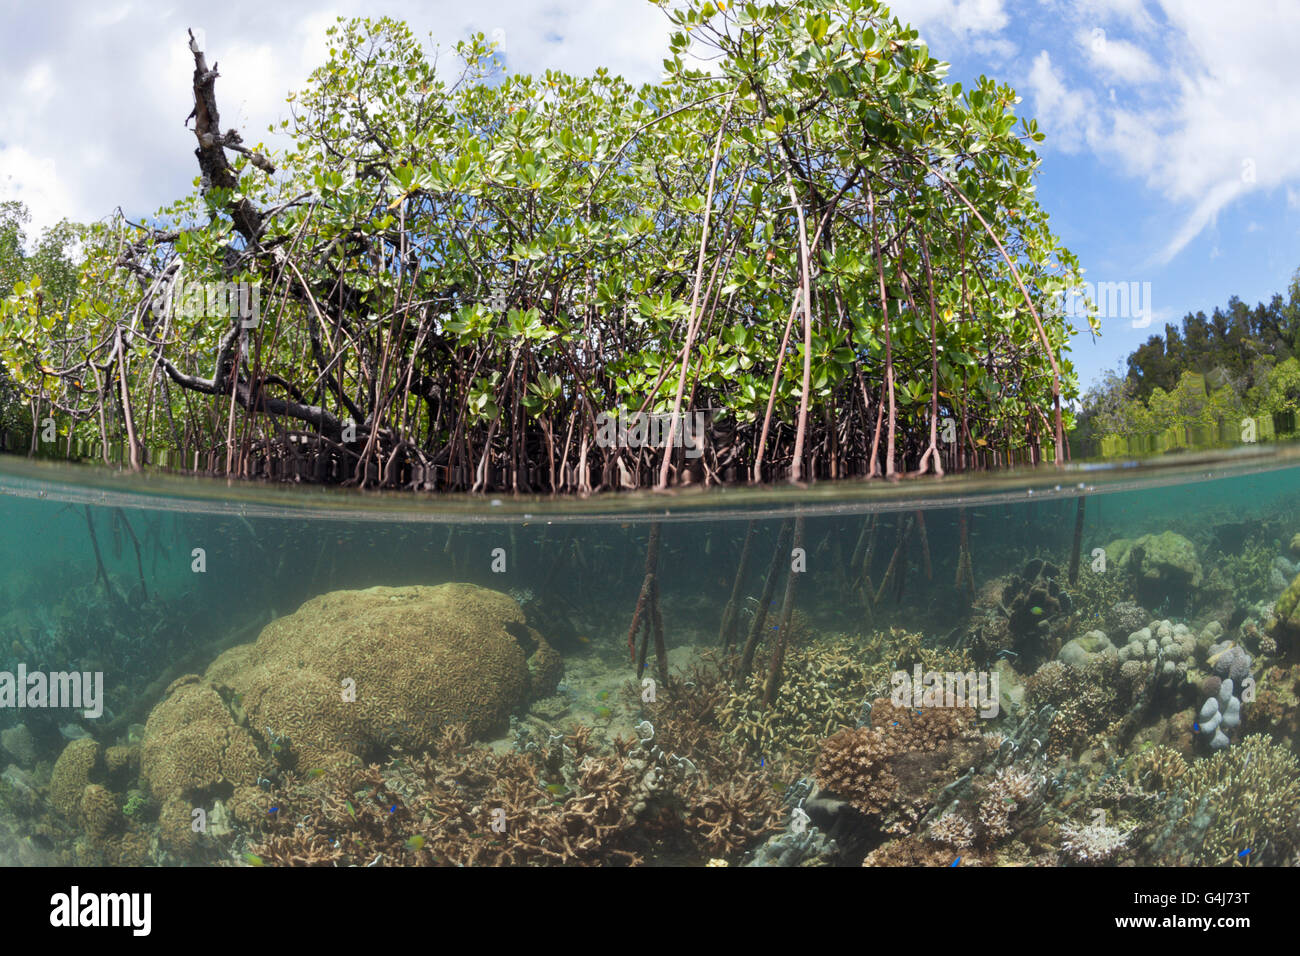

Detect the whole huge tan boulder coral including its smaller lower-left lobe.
xmin=142 ymin=584 xmax=563 ymax=800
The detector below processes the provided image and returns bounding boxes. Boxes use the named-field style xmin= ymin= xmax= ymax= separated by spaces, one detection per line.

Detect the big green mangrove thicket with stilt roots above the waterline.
xmin=0 ymin=0 xmax=1079 ymax=492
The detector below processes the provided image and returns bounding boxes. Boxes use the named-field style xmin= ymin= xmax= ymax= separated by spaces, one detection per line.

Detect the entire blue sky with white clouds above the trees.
xmin=0 ymin=0 xmax=1300 ymax=384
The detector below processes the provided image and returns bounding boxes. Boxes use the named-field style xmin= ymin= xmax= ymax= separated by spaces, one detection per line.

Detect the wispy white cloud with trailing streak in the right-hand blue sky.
xmin=1027 ymin=0 xmax=1300 ymax=264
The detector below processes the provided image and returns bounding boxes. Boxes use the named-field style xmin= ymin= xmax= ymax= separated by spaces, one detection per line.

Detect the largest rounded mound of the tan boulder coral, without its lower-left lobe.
xmin=208 ymin=584 xmax=563 ymax=782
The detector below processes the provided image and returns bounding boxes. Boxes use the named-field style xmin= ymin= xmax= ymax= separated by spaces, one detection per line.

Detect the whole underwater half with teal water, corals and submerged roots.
xmin=0 ymin=451 xmax=1300 ymax=866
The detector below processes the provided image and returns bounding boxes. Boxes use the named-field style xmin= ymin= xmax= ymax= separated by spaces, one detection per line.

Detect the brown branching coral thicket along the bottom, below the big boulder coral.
xmin=251 ymin=726 xmax=780 ymax=865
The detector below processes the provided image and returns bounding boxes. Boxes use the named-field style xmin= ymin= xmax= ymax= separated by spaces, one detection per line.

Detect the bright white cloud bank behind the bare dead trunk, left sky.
xmin=0 ymin=0 xmax=670 ymax=234
